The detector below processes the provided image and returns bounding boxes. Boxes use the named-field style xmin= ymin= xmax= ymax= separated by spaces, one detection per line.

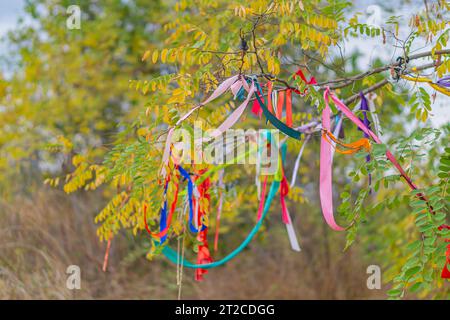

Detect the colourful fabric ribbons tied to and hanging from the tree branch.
xmin=144 ymin=70 xmax=450 ymax=280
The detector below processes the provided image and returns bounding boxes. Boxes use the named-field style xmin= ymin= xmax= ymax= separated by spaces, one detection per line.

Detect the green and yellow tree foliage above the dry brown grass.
xmin=0 ymin=0 xmax=450 ymax=298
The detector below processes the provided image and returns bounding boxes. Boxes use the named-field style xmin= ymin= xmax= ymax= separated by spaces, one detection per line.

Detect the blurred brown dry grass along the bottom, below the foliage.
xmin=0 ymin=189 xmax=383 ymax=299
